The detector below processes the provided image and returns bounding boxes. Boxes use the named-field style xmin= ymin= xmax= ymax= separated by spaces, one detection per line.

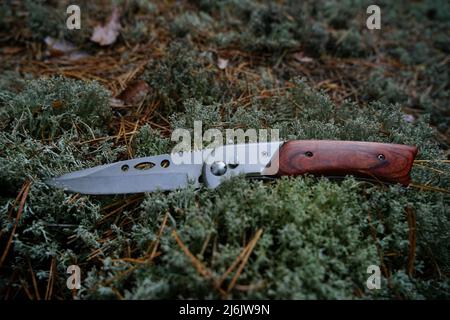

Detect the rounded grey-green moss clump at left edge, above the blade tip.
xmin=0 ymin=77 xmax=111 ymax=139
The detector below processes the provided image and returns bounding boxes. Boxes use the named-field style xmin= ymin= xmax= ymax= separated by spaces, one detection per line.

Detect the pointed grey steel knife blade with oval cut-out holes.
xmin=47 ymin=150 xmax=206 ymax=194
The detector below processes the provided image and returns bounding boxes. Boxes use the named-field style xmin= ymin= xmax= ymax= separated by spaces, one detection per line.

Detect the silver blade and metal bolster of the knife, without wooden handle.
xmin=47 ymin=141 xmax=283 ymax=194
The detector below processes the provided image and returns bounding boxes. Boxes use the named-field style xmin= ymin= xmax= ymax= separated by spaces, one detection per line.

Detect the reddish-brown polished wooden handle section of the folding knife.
xmin=277 ymin=140 xmax=417 ymax=185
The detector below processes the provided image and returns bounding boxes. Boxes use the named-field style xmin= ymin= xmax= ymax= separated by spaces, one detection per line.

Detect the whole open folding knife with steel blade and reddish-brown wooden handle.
xmin=47 ymin=140 xmax=417 ymax=194
